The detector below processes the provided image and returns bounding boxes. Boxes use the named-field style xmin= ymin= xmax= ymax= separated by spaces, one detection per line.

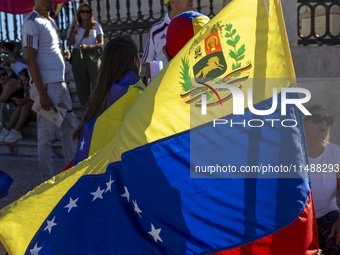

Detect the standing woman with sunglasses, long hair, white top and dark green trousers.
xmin=67 ymin=3 xmax=104 ymax=106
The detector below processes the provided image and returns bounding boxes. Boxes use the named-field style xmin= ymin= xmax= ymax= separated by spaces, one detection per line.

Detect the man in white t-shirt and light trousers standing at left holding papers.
xmin=21 ymin=0 xmax=79 ymax=181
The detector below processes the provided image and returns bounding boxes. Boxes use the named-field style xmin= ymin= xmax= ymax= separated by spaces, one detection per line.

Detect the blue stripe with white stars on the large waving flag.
xmin=26 ymin=94 xmax=310 ymax=254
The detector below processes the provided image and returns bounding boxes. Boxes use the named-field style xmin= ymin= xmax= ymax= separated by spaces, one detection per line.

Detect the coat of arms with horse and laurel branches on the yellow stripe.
xmin=180 ymin=21 xmax=252 ymax=107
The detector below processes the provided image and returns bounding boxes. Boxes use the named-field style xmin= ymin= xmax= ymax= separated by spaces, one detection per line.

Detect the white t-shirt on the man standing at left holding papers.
xmin=21 ymin=11 xmax=65 ymax=83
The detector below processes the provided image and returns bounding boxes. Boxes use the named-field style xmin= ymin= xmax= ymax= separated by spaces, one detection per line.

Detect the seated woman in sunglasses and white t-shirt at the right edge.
xmin=304 ymin=105 xmax=340 ymax=255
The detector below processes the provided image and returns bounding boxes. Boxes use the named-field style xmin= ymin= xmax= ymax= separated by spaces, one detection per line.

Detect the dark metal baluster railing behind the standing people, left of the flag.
xmin=0 ymin=0 xmax=218 ymax=53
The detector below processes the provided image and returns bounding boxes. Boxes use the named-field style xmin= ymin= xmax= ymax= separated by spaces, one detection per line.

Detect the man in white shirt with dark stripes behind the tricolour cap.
xmin=141 ymin=0 xmax=193 ymax=82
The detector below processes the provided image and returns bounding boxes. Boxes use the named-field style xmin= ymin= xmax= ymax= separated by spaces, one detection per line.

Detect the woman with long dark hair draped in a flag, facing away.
xmin=74 ymin=36 xmax=141 ymax=138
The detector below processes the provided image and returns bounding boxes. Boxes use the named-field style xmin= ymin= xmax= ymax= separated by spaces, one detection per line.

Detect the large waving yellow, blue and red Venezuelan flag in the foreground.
xmin=0 ymin=0 xmax=317 ymax=255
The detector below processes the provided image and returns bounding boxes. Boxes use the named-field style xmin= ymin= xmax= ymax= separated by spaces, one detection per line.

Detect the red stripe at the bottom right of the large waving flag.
xmin=215 ymin=194 xmax=319 ymax=255
